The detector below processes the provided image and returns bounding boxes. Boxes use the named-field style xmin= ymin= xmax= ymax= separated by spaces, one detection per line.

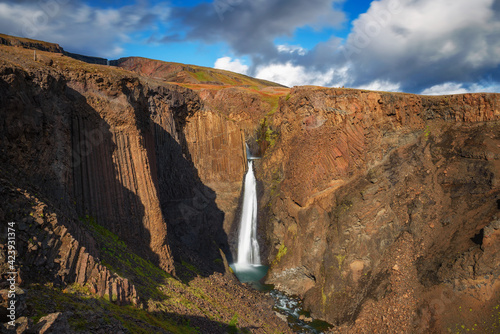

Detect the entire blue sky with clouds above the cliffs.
xmin=0 ymin=0 xmax=500 ymax=95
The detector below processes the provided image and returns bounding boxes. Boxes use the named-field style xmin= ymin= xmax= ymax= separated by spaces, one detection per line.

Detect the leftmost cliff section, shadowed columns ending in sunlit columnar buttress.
xmin=1 ymin=52 xmax=173 ymax=270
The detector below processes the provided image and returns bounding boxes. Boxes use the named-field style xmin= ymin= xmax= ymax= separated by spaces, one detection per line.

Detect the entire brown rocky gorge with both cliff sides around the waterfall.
xmin=0 ymin=36 xmax=500 ymax=333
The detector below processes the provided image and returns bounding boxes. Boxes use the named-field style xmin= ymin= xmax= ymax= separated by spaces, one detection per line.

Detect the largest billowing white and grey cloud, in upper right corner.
xmin=343 ymin=0 xmax=500 ymax=92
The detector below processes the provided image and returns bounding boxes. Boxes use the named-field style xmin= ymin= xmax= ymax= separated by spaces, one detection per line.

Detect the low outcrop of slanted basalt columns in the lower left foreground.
xmin=0 ymin=179 xmax=140 ymax=305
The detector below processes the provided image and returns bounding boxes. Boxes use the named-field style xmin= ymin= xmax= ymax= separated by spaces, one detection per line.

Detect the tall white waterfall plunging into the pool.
xmin=237 ymin=157 xmax=260 ymax=265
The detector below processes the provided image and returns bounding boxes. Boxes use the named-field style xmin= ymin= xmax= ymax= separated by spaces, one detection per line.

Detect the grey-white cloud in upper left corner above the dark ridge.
xmin=0 ymin=0 xmax=169 ymax=57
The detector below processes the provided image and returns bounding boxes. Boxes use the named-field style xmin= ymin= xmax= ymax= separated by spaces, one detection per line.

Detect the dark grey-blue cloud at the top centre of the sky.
xmin=172 ymin=0 xmax=345 ymax=59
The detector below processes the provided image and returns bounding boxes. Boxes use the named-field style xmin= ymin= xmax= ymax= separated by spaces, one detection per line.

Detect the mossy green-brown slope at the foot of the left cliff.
xmin=66 ymin=216 xmax=288 ymax=333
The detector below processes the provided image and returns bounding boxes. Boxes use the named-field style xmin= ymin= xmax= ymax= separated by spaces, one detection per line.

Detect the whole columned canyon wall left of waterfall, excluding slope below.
xmin=0 ymin=47 xmax=246 ymax=280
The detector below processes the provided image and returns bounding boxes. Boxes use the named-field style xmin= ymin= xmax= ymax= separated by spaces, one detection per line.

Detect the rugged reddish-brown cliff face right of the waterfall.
xmin=259 ymin=87 xmax=500 ymax=332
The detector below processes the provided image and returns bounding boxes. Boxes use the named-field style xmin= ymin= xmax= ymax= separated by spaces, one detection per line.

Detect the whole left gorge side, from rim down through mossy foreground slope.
xmin=0 ymin=41 xmax=287 ymax=333
